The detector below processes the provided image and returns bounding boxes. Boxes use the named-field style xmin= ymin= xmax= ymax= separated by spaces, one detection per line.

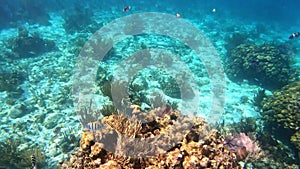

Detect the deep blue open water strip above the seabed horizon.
xmin=1 ymin=0 xmax=299 ymax=27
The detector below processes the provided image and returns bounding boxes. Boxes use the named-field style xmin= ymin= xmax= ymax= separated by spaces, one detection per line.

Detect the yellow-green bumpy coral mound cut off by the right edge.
xmin=262 ymin=82 xmax=300 ymax=160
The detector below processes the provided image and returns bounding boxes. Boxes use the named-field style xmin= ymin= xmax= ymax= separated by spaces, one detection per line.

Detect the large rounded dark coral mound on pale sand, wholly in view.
xmin=226 ymin=44 xmax=298 ymax=89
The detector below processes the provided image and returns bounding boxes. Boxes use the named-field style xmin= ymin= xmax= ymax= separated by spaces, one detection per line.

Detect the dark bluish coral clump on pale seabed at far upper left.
xmin=8 ymin=27 xmax=55 ymax=58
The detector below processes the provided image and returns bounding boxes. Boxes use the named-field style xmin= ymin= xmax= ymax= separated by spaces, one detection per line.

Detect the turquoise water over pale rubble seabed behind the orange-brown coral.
xmin=0 ymin=0 xmax=300 ymax=169
